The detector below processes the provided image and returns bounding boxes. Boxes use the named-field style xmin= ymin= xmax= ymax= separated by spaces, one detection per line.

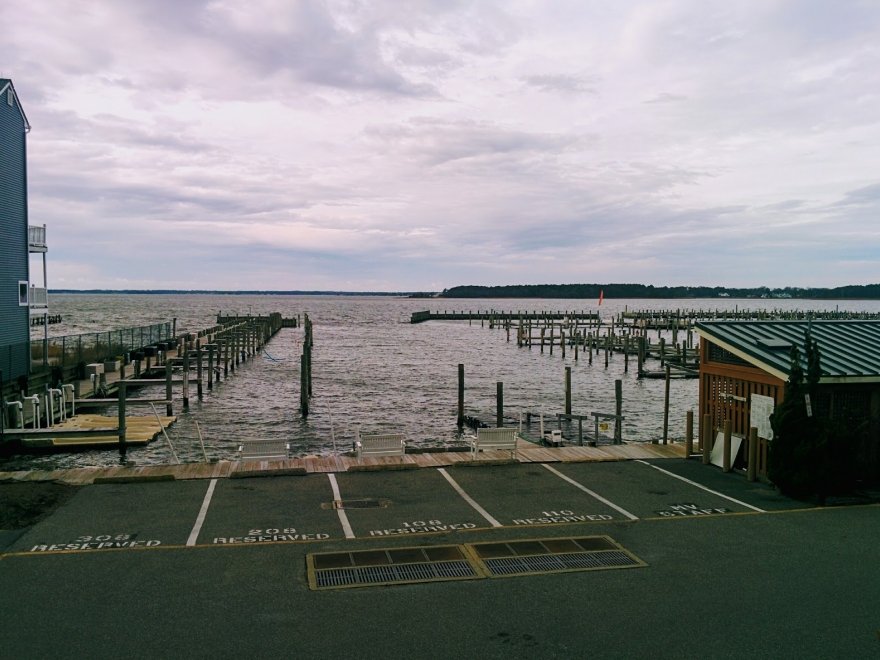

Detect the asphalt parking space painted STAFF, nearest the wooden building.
xmin=556 ymin=461 xmax=754 ymax=518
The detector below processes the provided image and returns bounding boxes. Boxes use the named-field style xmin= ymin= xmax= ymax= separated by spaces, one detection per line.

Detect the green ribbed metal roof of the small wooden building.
xmin=696 ymin=320 xmax=880 ymax=383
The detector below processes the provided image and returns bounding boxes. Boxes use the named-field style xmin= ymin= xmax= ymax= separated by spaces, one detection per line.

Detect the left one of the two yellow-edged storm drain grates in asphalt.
xmin=306 ymin=545 xmax=482 ymax=589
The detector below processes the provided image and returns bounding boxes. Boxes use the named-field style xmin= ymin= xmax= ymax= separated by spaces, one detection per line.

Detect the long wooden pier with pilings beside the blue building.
xmin=0 ymin=313 xmax=296 ymax=455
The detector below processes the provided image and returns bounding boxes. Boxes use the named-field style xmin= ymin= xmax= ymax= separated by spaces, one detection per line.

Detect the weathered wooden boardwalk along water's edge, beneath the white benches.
xmin=0 ymin=443 xmax=684 ymax=485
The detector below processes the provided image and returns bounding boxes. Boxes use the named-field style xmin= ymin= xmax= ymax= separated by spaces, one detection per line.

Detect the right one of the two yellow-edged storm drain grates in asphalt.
xmin=470 ymin=536 xmax=645 ymax=576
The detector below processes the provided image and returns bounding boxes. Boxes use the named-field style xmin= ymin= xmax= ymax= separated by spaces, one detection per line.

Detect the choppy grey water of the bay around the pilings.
xmin=8 ymin=294 xmax=880 ymax=469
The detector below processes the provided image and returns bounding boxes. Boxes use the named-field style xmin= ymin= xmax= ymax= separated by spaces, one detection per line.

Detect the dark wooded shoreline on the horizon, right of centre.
xmin=438 ymin=284 xmax=880 ymax=300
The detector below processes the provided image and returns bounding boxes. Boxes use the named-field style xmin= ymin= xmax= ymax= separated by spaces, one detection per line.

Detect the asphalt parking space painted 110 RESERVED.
xmin=448 ymin=464 xmax=633 ymax=526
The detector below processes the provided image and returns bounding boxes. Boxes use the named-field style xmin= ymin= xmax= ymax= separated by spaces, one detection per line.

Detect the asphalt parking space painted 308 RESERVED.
xmin=11 ymin=481 xmax=208 ymax=553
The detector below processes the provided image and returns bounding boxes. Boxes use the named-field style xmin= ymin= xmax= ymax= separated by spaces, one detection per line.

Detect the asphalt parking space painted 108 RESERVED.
xmin=335 ymin=469 xmax=491 ymax=538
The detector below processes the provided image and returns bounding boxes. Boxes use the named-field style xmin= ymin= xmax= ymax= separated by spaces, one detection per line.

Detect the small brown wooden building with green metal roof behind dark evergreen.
xmin=696 ymin=320 xmax=880 ymax=479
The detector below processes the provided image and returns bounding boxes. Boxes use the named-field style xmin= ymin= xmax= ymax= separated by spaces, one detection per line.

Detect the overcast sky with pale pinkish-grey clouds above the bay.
xmin=0 ymin=0 xmax=880 ymax=291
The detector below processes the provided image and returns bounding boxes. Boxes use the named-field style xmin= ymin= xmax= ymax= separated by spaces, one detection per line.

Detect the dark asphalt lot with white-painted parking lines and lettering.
xmin=0 ymin=460 xmax=880 ymax=658
